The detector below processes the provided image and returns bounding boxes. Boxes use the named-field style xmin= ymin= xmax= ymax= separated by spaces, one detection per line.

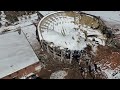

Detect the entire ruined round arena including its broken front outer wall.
xmin=38 ymin=11 xmax=107 ymax=63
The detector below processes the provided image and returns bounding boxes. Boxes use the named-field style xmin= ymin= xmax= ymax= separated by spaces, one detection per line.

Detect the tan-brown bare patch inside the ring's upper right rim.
xmin=66 ymin=11 xmax=105 ymax=30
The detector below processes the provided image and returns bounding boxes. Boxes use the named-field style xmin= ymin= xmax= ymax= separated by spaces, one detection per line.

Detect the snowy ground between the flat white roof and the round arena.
xmin=0 ymin=14 xmax=38 ymax=50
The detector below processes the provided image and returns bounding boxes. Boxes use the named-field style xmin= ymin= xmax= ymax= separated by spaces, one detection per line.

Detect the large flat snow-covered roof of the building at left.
xmin=0 ymin=32 xmax=39 ymax=78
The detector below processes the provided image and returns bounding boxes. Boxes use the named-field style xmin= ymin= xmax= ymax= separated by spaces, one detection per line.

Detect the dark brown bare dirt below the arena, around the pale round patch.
xmin=35 ymin=47 xmax=103 ymax=79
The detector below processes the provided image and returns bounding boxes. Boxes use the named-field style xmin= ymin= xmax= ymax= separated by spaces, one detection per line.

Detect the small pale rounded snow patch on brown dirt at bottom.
xmin=50 ymin=70 xmax=67 ymax=79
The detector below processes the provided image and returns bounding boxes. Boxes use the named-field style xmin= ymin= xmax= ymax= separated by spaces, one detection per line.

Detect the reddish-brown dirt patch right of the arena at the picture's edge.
xmin=94 ymin=46 xmax=120 ymax=69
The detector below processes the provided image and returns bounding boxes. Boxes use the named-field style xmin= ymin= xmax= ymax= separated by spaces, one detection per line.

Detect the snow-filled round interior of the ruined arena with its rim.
xmin=38 ymin=11 xmax=106 ymax=50
